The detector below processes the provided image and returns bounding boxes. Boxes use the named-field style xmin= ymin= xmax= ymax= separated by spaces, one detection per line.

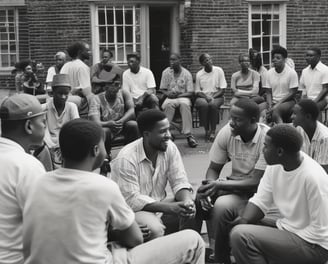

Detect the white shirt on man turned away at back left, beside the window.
xmin=60 ymin=59 xmax=91 ymax=95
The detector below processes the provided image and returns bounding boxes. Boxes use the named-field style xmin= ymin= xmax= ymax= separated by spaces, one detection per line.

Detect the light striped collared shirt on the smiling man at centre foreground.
xmin=111 ymin=138 xmax=191 ymax=212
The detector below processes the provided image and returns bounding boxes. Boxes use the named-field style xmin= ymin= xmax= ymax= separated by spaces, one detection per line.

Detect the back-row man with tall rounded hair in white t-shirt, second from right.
xmin=263 ymin=46 xmax=298 ymax=124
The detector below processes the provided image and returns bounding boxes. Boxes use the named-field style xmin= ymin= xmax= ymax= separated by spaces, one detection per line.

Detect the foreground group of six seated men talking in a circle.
xmin=0 ymin=92 xmax=328 ymax=264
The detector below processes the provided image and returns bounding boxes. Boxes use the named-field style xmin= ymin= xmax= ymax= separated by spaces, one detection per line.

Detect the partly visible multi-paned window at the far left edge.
xmin=0 ymin=8 xmax=18 ymax=69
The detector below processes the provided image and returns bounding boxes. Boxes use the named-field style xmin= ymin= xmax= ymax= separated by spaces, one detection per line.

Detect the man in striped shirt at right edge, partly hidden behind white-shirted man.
xmin=292 ymin=99 xmax=328 ymax=172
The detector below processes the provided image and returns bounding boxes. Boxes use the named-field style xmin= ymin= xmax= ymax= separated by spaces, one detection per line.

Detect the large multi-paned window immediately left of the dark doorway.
xmin=96 ymin=5 xmax=140 ymax=64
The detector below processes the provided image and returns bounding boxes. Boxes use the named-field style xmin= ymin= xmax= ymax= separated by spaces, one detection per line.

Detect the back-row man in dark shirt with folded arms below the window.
xmin=91 ymin=50 xmax=123 ymax=94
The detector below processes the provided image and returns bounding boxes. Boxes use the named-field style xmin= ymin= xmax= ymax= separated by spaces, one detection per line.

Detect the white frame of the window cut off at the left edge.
xmin=0 ymin=5 xmax=19 ymax=73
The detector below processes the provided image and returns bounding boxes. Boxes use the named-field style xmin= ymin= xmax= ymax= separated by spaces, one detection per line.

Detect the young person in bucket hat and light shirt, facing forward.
xmin=44 ymin=74 xmax=80 ymax=167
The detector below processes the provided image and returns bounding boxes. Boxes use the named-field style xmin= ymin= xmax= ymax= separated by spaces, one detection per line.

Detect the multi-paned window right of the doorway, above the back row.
xmin=249 ymin=3 xmax=286 ymax=67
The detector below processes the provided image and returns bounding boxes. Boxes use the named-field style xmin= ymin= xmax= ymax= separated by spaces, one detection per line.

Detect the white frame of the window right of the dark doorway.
xmin=248 ymin=0 xmax=287 ymax=67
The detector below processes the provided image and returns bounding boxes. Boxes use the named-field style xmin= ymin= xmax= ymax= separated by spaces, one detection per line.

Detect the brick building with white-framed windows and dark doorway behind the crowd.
xmin=0 ymin=0 xmax=328 ymax=99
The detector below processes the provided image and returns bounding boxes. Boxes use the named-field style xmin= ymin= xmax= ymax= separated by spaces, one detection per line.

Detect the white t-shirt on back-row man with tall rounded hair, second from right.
xmin=262 ymin=64 xmax=298 ymax=103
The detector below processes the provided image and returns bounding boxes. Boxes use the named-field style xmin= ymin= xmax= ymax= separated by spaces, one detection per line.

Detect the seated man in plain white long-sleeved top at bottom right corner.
xmin=230 ymin=124 xmax=328 ymax=264
